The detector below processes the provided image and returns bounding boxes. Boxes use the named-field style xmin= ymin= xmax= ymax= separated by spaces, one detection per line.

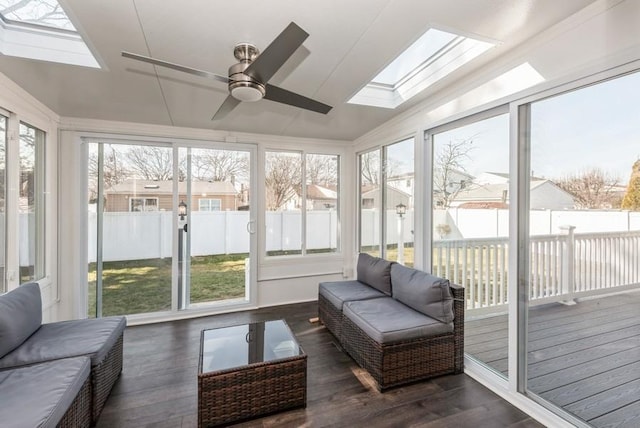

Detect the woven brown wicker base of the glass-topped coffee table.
xmin=198 ymin=355 xmax=307 ymax=427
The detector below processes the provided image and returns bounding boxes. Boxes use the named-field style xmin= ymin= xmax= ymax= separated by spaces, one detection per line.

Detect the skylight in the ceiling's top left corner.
xmin=0 ymin=0 xmax=100 ymax=68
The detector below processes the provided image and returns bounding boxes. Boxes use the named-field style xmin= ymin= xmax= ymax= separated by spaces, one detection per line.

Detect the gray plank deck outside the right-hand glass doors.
xmin=465 ymin=292 xmax=640 ymax=427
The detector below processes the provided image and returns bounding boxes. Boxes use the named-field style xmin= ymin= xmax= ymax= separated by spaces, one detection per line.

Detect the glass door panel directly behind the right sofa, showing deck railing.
xmin=432 ymin=114 xmax=509 ymax=377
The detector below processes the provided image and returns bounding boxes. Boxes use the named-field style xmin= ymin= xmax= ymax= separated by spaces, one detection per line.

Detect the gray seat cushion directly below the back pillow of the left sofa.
xmin=0 ymin=317 xmax=126 ymax=368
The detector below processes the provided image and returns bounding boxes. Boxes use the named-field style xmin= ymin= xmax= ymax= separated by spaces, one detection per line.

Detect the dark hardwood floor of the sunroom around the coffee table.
xmin=98 ymin=303 xmax=542 ymax=428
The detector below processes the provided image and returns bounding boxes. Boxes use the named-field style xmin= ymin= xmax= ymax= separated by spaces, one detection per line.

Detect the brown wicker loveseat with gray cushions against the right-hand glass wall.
xmin=318 ymin=253 xmax=464 ymax=391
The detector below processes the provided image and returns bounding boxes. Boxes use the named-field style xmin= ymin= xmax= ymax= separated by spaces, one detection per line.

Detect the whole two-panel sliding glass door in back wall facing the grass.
xmin=88 ymin=141 xmax=255 ymax=316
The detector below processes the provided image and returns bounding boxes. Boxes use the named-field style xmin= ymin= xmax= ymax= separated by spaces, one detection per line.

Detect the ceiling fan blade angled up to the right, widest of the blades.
xmin=244 ymin=22 xmax=309 ymax=83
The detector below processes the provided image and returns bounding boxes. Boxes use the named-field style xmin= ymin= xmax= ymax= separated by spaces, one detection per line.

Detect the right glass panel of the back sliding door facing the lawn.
xmin=184 ymin=148 xmax=255 ymax=307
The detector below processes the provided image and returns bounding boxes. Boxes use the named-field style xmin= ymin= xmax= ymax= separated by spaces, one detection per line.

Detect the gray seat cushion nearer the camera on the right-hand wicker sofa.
xmin=342 ymin=297 xmax=453 ymax=344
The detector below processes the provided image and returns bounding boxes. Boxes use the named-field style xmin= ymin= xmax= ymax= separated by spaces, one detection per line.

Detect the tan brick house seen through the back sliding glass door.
xmin=105 ymin=180 xmax=241 ymax=212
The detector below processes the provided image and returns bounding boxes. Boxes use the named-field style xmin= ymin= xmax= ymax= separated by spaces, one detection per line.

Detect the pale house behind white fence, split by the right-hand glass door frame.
xmin=451 ymin=173 xmax=575 ymax=210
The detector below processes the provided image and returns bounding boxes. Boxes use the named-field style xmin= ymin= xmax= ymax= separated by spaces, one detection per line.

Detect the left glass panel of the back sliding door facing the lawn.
xmin=88 ymin=143 xmax=174 ymax=317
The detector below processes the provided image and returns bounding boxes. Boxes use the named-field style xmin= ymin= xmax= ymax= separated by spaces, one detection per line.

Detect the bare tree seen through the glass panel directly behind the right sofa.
xmin=433 ymin=138 xmax=473 ymax=208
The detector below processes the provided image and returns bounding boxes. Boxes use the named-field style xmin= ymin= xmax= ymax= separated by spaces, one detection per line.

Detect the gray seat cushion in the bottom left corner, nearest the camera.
xmin=0 ymin=357 xmax=91 ymax=428
